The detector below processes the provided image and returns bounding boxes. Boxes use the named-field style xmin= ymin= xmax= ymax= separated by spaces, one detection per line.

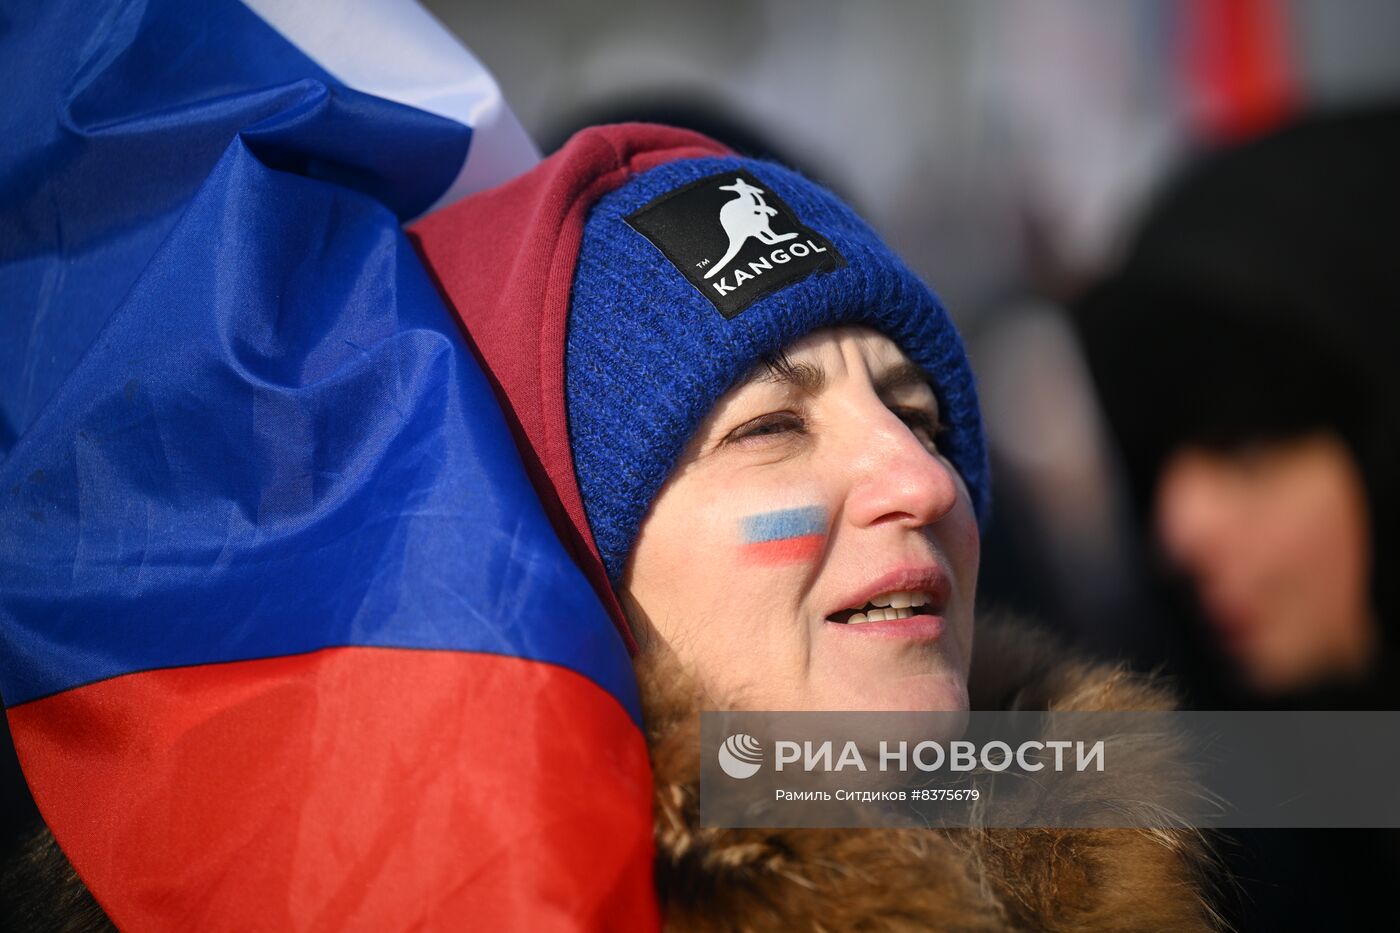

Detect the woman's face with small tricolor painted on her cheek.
xmin=623 ymin=328 xmax=980 ymax=710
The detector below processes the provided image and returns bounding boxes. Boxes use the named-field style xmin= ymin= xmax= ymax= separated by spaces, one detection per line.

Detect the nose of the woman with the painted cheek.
xmin=847 ymin=406 xmax=959 ymax=528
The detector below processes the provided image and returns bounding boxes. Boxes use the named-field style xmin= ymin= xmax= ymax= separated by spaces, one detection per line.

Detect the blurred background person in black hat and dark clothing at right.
xmin=1075 ymin=106 xmax=1400 ymax=930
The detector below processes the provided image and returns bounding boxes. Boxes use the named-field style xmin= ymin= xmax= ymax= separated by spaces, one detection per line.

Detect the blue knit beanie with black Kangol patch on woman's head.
xmin=564 ymin=157 xmax=990 ymax=584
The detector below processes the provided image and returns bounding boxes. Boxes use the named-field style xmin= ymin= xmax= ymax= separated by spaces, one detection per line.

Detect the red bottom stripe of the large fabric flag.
xmin=8 ymin=647 xmax=659 ymax=930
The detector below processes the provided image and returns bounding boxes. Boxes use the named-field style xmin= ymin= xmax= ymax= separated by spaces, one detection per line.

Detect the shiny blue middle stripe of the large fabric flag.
xmin=0 ymin=0 xmax=640 ymax=720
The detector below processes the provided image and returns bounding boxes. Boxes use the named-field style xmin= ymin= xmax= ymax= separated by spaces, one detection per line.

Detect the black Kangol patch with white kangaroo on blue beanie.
xmin=627 ymin=170 xmax=846 ymax=318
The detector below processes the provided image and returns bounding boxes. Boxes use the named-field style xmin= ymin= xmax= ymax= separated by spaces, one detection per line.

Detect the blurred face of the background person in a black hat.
xmin=1156 ymin=433 xmax=1376 ymax=693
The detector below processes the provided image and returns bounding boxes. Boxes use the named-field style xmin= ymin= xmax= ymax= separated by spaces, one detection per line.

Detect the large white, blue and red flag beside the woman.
xmin=0 ymin=0 xmax=657 ymax=930
